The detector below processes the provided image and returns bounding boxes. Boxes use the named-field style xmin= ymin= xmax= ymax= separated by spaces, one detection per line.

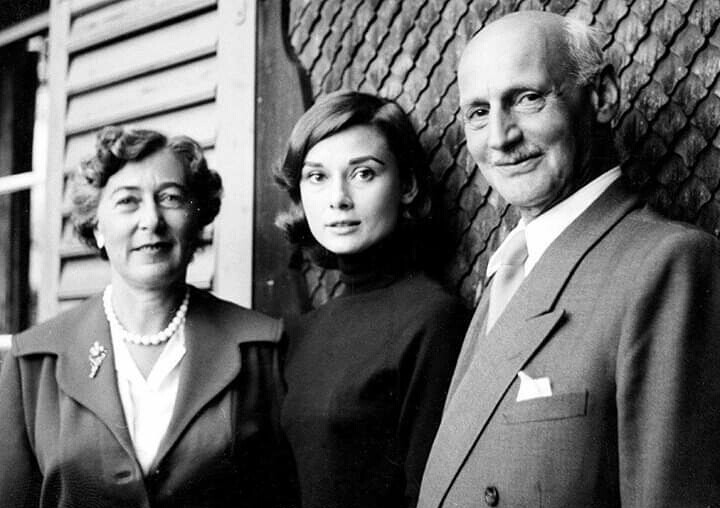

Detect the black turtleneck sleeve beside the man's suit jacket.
xmin=398 ymin=297 xmax=470 ymax=508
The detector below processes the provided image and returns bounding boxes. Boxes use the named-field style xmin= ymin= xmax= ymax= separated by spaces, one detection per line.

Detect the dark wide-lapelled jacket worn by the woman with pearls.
xmin=0 ymin=290 xmax=291 ymax=508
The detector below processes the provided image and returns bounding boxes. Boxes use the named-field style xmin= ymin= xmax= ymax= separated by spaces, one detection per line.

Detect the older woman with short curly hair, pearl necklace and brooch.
xmin=0 ymin=127 xmax=292 ymax=508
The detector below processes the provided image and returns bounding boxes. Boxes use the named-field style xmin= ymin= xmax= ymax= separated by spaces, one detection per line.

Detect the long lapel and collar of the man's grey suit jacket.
xmin=419 ymin=179 xmax=637 ymax=508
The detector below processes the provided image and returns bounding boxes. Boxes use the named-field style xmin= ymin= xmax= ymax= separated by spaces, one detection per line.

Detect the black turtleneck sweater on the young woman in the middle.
xmin=282 ymin=253 xmax=469 ymax=508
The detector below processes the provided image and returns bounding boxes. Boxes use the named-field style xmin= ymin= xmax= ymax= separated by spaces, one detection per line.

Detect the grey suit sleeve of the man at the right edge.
xmin=616 ymin=232 xmax=720 ymax=508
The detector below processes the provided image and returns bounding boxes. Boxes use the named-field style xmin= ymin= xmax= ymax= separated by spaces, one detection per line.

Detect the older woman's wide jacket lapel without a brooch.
xmin=153 ymin=291 xmax=241 ymax=467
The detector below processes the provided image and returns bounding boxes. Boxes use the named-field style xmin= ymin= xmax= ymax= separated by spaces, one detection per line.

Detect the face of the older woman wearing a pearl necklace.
xmin=95 ymin=150 xmax=199 ymax=289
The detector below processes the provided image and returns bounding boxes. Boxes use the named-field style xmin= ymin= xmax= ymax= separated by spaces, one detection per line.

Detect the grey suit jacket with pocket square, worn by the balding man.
xmin=418 ymin=182 xmax=720 ymax=508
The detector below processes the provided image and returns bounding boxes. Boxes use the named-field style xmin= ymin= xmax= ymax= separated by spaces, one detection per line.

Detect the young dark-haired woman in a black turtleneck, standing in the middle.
xmin=278 ymin=92 xmax=467 ymax=508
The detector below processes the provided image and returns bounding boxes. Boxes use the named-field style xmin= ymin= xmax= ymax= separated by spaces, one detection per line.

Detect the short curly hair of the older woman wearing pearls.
xmin=69 ymin=126 xmax=223 ymax=258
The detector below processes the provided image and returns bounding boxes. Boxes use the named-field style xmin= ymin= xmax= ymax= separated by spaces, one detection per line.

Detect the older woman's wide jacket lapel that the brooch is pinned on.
xmin=57 ymin=296 xmax=135 ymax=457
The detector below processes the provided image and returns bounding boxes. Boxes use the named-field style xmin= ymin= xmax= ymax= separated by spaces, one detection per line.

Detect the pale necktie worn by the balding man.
xmin=485 ymin=230 xmax=527 ymax=331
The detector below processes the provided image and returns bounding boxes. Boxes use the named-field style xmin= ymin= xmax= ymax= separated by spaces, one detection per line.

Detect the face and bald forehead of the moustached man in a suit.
xmin=458 ymin=20 xmax=590 ymax=220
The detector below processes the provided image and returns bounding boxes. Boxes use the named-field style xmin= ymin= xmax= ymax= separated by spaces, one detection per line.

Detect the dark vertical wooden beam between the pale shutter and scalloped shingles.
xmin=254 ymin=0 xmax=311 ymax=317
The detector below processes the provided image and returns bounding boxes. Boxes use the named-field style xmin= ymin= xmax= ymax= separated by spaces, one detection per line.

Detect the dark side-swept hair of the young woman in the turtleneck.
xmin=275 ymin=91 xmax=432 ymax=267
